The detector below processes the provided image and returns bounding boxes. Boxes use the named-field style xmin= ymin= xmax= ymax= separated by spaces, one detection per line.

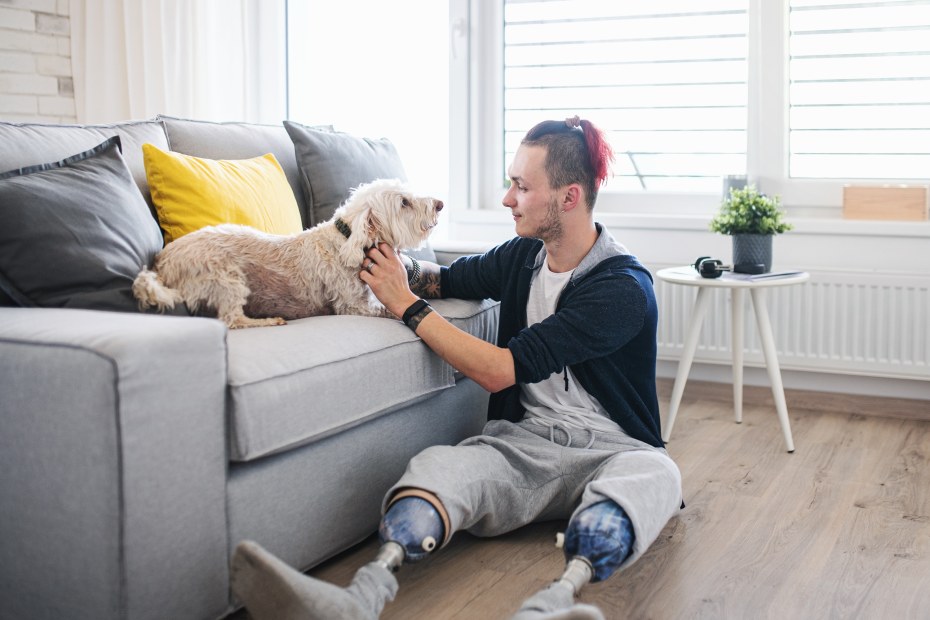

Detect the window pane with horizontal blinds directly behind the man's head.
xmin=504 ymin=0 xmax=748 ymax=191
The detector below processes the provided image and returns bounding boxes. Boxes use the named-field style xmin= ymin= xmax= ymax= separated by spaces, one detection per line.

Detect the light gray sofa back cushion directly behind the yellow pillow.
xmin=157 ymin=115 xmax=310 ymax=228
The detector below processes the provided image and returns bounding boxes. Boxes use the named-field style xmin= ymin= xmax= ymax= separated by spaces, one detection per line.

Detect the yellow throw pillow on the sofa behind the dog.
xmin=142 ymin=144 xmax=303 ymax=244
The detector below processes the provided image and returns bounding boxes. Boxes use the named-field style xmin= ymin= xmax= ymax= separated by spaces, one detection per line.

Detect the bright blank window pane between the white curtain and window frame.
xmin=287 ymin=0 xmax=449 ymax=197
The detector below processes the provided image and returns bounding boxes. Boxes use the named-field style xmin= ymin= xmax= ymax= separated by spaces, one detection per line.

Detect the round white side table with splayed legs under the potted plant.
xmin=656 ymin=266 xmax=810 ymax=452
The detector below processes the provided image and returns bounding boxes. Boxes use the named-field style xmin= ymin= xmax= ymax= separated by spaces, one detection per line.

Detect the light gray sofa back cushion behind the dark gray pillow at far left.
xmin=0 ymin=120 xmax=168 ymax=213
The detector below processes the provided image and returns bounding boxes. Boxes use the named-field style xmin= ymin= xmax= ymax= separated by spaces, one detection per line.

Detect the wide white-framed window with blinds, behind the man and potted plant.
xmin=464 ymin=0 xmax=930 ymax=213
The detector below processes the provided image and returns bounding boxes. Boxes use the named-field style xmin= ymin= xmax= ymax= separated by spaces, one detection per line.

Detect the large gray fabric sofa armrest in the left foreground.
xmin=0 ymin=308 xmax=228 ymax=619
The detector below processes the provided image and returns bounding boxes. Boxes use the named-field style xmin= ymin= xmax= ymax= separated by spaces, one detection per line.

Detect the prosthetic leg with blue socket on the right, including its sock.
xmin=513 ymin=501 xmax=634 ymax=620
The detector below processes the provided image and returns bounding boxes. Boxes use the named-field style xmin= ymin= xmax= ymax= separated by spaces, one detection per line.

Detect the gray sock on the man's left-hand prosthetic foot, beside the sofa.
xmin=230 ymin=541 xmax=398 ymax=620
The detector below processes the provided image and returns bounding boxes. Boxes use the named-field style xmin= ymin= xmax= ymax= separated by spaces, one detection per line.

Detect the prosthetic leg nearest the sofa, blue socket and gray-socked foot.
xmin=230 ymin=490 xmax=449 ymax=620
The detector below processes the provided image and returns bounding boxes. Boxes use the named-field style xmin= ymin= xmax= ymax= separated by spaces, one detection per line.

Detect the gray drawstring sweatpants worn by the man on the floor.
xmin=384 ymin=420 xmax=681 ymax=568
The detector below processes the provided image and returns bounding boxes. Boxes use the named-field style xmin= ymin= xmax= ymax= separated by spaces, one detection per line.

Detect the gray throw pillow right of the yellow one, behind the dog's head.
xmin=284 ymin=121 xmax=407 ymax=226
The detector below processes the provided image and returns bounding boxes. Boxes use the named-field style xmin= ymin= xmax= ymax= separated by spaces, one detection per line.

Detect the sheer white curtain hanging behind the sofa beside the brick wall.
xmin=71 ymin=0 xmax=286 ymax=123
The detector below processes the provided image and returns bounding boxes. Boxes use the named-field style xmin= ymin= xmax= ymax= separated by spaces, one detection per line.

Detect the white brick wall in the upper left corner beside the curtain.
xmin=0 ymin=0 xmax=75 ymax=123
